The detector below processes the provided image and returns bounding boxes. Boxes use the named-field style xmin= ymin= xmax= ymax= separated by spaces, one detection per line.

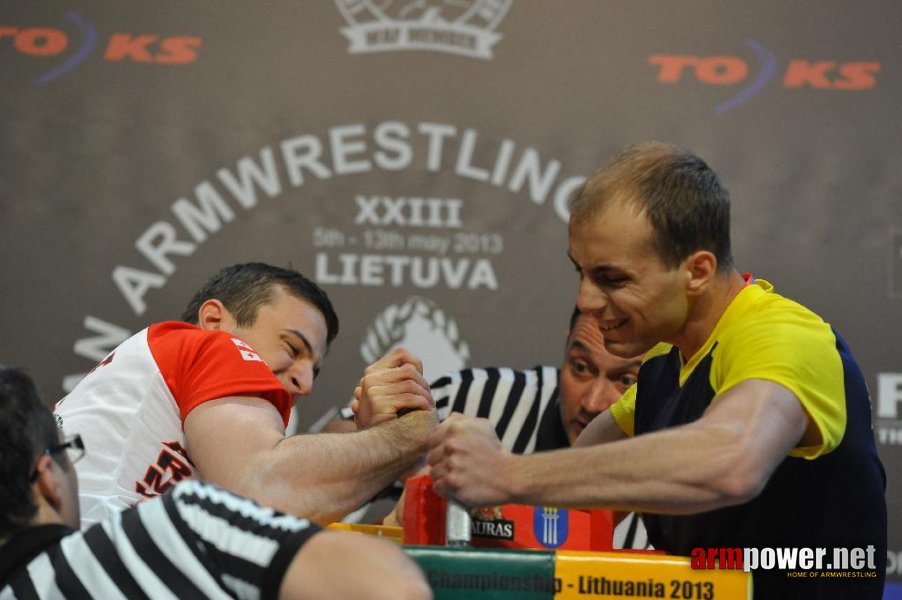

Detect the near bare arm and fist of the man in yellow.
xmin=429 ymin=380 xmax=809 ymax=514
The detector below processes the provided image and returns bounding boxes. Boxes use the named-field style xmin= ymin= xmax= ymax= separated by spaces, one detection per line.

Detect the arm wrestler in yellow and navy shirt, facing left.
xmin=429 ymin=142 xmax=886 ymax=600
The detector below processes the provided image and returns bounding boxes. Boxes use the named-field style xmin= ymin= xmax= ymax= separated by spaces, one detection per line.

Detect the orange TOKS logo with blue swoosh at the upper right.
xmin=648 ymin=39 xmax=880 ymax=114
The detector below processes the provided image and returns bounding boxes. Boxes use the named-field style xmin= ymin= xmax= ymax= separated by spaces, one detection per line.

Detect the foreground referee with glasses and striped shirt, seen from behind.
xmin=0 ymin=366 xmax=431 ymax=600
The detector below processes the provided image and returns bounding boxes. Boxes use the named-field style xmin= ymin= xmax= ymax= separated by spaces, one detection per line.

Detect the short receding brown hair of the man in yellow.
xmin=570 ymin=142 xmax=733 ymax=272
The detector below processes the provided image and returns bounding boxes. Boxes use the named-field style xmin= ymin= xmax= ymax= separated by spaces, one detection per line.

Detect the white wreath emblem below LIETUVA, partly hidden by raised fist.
xmin=360 ymin=296 xmax=470 ymax=381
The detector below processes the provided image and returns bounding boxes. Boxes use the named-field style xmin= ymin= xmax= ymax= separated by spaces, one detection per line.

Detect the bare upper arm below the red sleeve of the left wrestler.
xmin=184 ymin=396 xmax=285 ymax=492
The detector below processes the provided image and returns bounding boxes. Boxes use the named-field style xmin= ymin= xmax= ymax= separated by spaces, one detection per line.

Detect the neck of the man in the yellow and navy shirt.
xmin=672 ymin=269 xmax=745 ymax=361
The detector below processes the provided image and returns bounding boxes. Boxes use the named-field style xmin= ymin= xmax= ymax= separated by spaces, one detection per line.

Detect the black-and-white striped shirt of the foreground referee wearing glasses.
xmin=0 ymin=480 xmax=320 ymax=600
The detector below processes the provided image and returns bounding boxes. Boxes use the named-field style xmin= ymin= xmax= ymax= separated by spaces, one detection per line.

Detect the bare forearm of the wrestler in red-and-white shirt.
xmin=254 ymin=411 xmax=435 ymax=523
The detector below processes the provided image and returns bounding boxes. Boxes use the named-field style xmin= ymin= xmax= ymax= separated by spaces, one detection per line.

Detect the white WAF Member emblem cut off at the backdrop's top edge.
xmin=335 ymin=0 xmax=512 ymax=60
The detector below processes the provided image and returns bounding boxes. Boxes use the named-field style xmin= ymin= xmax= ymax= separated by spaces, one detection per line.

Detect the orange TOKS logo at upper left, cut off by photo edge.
xmin=0 ymin=12 xmax=203 ymax=86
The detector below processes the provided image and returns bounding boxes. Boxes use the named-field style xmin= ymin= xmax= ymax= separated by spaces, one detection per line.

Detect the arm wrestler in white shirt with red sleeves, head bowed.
xmin=54 ymin=263 xmax=435 ymax=525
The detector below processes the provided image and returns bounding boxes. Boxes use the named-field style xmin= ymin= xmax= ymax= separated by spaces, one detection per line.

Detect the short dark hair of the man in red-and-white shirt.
xmin=181 ymin=263 xmax=338 ymax=344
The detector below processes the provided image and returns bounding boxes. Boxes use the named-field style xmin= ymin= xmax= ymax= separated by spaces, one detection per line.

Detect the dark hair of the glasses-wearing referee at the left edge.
xmin=0 ymin=365 xmax=59 ymax=538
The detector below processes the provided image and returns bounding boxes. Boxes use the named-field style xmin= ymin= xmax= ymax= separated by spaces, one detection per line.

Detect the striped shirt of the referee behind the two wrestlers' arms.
xmin=432 ymin=366 xmax=650 ymax=549
